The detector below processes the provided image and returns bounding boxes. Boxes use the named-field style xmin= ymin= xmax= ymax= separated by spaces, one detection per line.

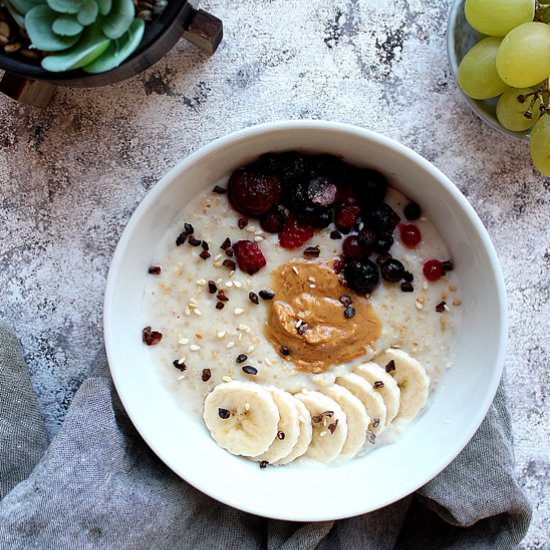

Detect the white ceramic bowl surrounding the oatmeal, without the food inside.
xmin=104 ymin=121 xmax=506 ymax=521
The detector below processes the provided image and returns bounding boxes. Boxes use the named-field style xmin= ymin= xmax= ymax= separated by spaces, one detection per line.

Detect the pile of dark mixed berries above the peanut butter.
xmin=227 ymin=151 xmax=430 ymax=294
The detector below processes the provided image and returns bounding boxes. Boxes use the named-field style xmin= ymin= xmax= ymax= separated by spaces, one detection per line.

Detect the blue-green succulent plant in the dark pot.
xmin=3 ymin=0 xmax=145 ymax=73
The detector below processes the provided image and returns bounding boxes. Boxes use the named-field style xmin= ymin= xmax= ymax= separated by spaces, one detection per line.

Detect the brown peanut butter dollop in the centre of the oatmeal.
xmin=265 ymin=261 xmax=381 ymax=373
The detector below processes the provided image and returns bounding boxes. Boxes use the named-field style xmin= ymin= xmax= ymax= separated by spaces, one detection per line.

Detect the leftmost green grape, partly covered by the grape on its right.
xmin=457 ymin=37 xmax=506 ymax=99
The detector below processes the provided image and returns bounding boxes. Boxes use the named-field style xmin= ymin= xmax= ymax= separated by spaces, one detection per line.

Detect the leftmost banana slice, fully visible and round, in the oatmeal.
xmin=203 ymin=381 xmax=279 ymax=456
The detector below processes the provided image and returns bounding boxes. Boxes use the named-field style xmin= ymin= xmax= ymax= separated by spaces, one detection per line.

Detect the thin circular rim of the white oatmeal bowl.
xmin=103 ymin=120 xmax=508 ymax=522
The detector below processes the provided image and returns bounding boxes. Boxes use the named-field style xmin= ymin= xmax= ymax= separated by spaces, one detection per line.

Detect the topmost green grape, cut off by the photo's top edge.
xmin=464 ymin=0 xmax=535 ymax=36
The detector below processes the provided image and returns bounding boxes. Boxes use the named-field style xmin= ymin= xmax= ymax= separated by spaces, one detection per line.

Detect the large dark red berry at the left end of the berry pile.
xmin=227 ymin=170 xmax=281 ymax=217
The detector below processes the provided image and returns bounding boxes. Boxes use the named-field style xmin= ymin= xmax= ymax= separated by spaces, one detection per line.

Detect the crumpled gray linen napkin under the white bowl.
xmin=0 ymin=326 xmax=531 ymax=550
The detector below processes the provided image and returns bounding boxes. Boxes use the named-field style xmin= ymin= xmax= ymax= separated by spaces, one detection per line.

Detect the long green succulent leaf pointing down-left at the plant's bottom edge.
xmin=42 ymin=23 xmax=111 ymax=73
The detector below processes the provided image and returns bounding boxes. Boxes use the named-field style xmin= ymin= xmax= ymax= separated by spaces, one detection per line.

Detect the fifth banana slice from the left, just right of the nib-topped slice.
xmin=320 ymin=384 xmax=370 ymax=458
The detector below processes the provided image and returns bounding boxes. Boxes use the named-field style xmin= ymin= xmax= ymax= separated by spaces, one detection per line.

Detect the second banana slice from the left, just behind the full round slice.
xmin=254 ymin=388 xmax=300 ymax=464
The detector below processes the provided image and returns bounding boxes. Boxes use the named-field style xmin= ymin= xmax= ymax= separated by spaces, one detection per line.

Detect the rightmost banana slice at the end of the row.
xmin=374 ymin=349 xmax=430 ymax=420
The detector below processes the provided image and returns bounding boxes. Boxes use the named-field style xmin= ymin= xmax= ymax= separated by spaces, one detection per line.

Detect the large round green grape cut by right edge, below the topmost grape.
xmin=497 ymin=23 xmax=550 ymax=88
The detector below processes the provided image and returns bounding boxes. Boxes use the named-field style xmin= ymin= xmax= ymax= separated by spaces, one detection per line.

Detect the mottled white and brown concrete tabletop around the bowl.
xmin=0 ymin=0 xmax=550 ymax=549
